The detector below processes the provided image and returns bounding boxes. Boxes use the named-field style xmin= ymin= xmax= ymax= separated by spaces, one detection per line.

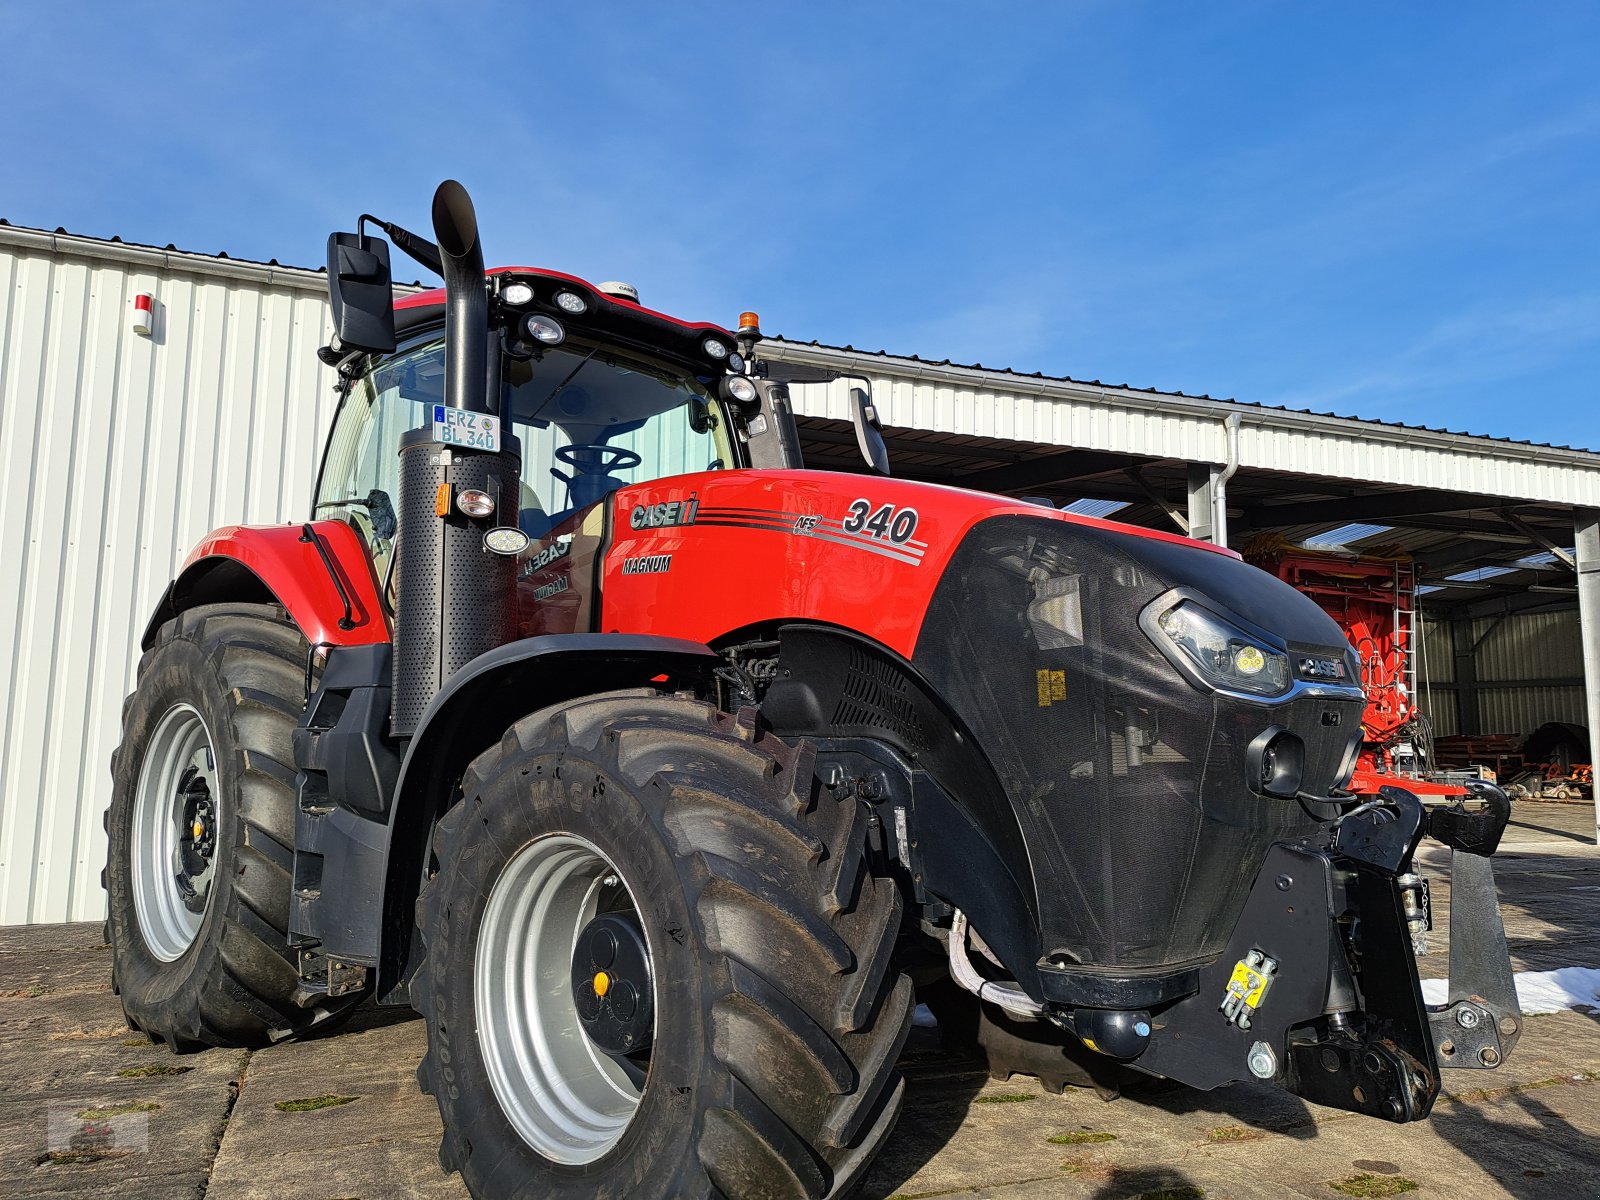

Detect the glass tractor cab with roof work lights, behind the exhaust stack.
xmin=315 ymin=267 xmax=774 ymax=601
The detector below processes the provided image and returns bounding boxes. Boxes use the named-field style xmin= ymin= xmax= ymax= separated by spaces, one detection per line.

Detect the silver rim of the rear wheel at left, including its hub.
xmin=131 ymin=704 xmax=218 ymax=963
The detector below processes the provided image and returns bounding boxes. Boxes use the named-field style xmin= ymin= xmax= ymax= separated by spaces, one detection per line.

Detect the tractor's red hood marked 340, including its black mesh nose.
xmin=602 ymin=470 xmax=1363 ymax=1003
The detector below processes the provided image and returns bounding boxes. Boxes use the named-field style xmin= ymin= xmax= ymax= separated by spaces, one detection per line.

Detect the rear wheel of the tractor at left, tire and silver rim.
xmin=101 ymin=603 xmax=360 ymax=1051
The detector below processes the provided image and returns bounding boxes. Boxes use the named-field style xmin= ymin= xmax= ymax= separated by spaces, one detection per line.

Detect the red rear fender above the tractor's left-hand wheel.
xmin=141 ymin=520 xmax=390 ymax=650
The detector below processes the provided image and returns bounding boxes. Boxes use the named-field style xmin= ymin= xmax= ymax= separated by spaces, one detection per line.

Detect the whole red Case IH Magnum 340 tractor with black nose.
xmin=106 ymin=182 xmax=1522 ymax=1198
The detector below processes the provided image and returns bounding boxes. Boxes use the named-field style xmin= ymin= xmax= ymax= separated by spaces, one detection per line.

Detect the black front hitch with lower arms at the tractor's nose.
xmin=1136 ymin=782 xmax=1522 ymax=1122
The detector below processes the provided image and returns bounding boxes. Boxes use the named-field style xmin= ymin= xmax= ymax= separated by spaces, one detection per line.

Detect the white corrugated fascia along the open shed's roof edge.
xmin=762 ymin=342 xmax=1600 ymax=507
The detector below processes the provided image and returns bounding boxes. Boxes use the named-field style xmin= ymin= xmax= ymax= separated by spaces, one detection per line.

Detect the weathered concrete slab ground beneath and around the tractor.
xmin=0 ymin=803 xmax=1600 ymax=1200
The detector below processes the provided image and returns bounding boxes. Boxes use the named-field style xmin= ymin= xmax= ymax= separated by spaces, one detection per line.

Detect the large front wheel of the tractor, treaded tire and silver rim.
xmin=411 ymin=691 xmax=912 ymax=1200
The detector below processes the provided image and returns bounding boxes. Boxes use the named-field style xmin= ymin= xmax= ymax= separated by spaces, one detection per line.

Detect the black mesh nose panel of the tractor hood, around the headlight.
xmin=915 ymin=517 xmax=1362 ymax=978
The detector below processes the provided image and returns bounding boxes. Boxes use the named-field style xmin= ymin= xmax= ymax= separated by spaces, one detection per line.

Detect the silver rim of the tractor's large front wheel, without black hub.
xmin=474 ymin=834 xmax=654 ymax=1165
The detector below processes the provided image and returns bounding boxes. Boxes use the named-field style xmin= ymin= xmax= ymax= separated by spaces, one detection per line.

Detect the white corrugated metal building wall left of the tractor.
xmin=0 ymin=229 xmax=334 ymax=925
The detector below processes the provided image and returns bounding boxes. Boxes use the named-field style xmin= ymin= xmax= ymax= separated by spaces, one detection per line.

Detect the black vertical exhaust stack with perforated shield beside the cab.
xmin=390 ymin=179 xmax=522 ymax=738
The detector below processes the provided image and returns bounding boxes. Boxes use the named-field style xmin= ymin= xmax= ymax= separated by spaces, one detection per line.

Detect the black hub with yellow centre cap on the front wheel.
xmin=573 ymin=912 xmax=656 ymax=1056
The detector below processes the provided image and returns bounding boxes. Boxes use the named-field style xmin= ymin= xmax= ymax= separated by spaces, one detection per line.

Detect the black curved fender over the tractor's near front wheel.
xmin=371 ymin=634 xmax=722 ymax=1003
